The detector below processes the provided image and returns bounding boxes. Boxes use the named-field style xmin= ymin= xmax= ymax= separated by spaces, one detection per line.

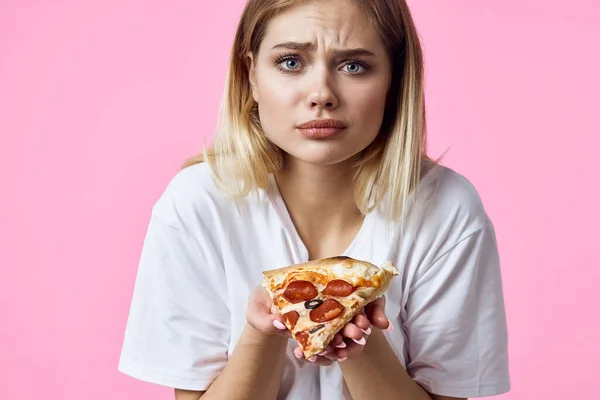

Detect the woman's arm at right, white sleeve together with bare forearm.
xmin=340 ymin=225 xmax=510 ymax=400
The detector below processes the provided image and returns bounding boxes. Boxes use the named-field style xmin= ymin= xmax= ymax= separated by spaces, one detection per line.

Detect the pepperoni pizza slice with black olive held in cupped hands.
xmin=262 ymin=257 xmax=399 ymax=358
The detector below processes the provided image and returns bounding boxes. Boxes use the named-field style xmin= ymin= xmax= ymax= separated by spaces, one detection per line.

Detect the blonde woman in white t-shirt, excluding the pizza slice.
xmin=119 ymin=0 xmax=510 ymax=400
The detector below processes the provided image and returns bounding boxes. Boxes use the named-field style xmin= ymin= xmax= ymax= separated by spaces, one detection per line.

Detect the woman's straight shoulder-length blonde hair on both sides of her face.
xmin=183 ymin=0 xmax=432 ymax=220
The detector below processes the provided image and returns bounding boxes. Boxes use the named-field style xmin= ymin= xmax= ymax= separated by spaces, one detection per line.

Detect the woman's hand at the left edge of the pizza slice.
xmin=246 ymin=286 xmax=292 ymax=337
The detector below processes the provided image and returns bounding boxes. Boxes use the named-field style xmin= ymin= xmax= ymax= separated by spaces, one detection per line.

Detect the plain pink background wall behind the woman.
xmin=0 ymin=0 xmax=600 ymax=400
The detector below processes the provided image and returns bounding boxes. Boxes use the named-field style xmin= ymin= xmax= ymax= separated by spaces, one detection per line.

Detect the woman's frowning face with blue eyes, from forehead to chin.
xmin=250 ymin=0 xmax=391 ymax=165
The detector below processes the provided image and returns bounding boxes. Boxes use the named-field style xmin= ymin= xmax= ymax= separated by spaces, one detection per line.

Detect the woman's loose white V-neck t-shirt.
xmin=119 ymin=164 xmax=510 ymax=400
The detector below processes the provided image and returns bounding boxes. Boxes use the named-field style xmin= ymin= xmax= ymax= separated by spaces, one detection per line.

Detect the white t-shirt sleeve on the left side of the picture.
xmin=118 ymin=214 xmax=230 ymax=390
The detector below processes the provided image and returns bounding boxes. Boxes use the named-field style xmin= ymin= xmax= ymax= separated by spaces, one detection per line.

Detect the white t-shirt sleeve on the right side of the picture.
xmin=404 ymin=221 xmax=510 ymax=398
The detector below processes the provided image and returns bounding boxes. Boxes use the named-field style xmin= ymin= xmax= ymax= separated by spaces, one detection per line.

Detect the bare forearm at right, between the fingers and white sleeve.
xmin=340 ymin=329 xmax=464 ymax=400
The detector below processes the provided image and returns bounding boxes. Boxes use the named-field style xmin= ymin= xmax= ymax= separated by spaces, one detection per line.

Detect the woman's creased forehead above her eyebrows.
xmin=261 ymin=0 xmax=384 ymax=50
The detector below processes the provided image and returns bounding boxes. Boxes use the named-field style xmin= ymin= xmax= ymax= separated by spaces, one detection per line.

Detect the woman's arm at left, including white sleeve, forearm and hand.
xmin=119 ymin=217 xmax=289 ymax=400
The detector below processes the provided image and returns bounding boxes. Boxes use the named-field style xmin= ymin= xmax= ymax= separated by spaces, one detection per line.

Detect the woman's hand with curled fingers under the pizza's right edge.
xmin=294 ymin=296 xmax=391 ymax=366
